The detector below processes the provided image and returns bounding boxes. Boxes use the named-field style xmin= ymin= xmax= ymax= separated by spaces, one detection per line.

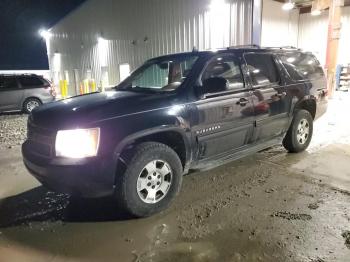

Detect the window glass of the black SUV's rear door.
xmin=244 ymin=54 xmax=280 ymax=86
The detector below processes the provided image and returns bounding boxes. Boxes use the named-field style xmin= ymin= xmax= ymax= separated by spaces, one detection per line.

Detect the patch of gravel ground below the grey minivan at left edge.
xmin=0 ymin=114 xmax=28 ymax=148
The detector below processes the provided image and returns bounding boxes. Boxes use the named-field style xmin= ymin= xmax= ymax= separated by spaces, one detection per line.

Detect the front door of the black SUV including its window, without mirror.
xmin=192 ymin=54 xmax=254 ymax=160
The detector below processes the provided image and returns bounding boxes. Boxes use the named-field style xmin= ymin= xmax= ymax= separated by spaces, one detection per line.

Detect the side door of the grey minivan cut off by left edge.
xmin=0 ymin=76 xmax=23 ymax=111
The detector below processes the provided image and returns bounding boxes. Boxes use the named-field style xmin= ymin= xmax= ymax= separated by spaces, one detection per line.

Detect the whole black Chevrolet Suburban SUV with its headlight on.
xmin=22 ymin=47 xmax=327 ymax=217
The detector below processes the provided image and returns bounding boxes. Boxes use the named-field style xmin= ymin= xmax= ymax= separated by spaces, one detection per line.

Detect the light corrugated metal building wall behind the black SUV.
xmin=47 ymin=0 xmax=252 ymax=94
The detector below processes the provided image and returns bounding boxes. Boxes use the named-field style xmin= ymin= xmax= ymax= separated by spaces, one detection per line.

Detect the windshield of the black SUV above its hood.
xmin=117 ymin=55 xmax=198 ymax=91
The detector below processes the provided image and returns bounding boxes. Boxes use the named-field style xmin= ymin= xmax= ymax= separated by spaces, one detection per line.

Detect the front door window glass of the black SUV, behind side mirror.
xmin=201 ymin=56 xmax=244 ymax=91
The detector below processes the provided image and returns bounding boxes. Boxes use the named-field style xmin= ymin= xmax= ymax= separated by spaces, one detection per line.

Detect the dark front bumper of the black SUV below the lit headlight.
xmin=22 ymin=141 xmax=116 ymax=198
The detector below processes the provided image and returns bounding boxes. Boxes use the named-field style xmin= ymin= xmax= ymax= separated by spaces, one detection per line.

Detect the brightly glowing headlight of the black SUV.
xmin=55 ymin=128 xmax=100 ymax=158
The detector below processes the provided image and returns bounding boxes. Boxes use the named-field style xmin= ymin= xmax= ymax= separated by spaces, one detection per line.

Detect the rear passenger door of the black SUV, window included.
xmin=244 ymin=53 xmax=291 ymax=141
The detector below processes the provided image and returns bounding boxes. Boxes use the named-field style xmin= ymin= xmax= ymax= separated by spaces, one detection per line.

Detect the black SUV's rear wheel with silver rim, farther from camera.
xmin=283 ymin=110 xmax=313 ymax=153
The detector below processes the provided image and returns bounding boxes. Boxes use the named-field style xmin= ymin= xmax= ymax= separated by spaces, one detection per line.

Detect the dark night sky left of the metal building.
xmin=0 ymin=0 xmax=85 ymax=70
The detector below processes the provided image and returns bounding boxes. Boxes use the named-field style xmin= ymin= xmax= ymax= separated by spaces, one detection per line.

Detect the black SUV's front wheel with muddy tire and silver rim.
xmin=115 ymin=142 xmax=183 ymax=217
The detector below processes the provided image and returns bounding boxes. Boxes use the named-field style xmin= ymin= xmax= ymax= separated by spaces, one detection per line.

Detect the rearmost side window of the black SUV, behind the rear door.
xmin=278 ymin=52 xmax=324 ymax=81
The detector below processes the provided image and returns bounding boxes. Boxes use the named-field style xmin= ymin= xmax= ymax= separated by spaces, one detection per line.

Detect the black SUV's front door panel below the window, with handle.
xmin=193 ymin=91 xmax=254 ymax=159
